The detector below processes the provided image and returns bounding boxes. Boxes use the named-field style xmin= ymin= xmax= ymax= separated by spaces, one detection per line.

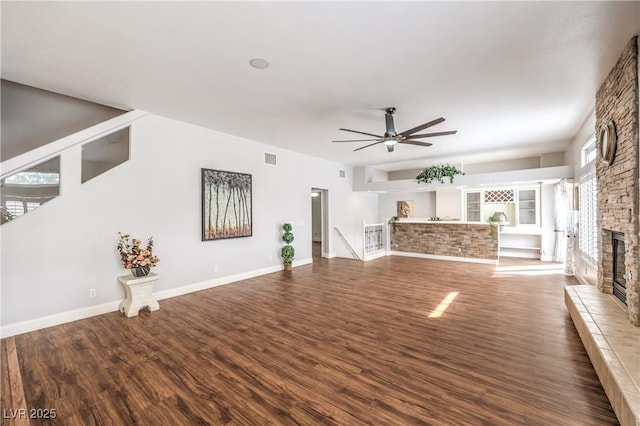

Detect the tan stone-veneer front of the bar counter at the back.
xmin=390 ymin=222 xmax=498 ymax=260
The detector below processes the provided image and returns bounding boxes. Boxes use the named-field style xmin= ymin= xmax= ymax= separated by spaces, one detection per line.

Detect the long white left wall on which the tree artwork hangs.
xmin=1 ymin=115 xmax=378 ymax=329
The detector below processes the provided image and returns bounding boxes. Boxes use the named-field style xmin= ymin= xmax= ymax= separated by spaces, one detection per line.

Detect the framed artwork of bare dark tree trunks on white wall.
xmin=202 ymin=169 xmax=253 ymax=241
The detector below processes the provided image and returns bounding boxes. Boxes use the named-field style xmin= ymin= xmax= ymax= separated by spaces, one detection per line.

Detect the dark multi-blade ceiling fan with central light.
xmin=332 ymin=108 xmax=457 ymax=152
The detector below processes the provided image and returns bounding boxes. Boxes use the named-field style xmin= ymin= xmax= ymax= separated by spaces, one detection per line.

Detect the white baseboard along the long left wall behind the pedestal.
xmin=0 ymin=258 xmax=313 ymax=338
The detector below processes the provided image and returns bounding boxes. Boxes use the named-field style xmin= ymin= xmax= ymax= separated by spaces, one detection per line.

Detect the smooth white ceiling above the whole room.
xmin=1 ymin=1 xmax=640 ymax=170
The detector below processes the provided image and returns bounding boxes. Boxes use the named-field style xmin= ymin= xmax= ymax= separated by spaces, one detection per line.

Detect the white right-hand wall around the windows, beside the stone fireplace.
xmin=565 ymin=110 xmax=598 ymax=285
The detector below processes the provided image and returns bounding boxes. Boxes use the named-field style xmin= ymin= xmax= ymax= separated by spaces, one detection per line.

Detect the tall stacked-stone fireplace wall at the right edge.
xmin=596 ymin=37 xmax=640 ymax=326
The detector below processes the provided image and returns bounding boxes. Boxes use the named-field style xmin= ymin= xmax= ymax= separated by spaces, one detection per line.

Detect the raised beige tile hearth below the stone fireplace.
xmin=565 ymin=285 xmax=640 ymax=426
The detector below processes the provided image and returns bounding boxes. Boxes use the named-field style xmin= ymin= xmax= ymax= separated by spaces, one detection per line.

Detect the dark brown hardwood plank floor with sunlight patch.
xmin=1 ymin=257 xmax=618 ymax=426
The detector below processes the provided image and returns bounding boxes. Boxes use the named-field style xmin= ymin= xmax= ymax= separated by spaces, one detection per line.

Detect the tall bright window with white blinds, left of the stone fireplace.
xmin=579 ymin=172 xmax=598 ymax=264
